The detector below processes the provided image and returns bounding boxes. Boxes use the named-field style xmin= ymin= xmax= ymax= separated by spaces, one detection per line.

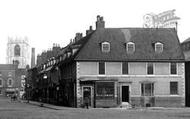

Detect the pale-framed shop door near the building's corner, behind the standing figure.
xmin=83 ymin=86 xmax=92 ymax=106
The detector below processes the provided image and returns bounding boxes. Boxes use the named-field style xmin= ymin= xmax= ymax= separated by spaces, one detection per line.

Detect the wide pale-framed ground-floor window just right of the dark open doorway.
xmin=141 ymin=83 xmax=154 ymax=96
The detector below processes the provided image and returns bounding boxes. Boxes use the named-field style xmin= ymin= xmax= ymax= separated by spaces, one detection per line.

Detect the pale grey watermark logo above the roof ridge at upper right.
xmin=143 ymin=10 xmax=180 ymax=28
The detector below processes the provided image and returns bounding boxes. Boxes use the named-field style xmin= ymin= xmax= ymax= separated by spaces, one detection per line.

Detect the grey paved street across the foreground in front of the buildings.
xmin=0 ymin=97 xmax=190 ymax=119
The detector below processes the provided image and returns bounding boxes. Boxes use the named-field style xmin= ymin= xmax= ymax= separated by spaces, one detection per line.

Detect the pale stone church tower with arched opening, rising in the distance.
xmin=6 ymin=37 xmax=30 ymax=68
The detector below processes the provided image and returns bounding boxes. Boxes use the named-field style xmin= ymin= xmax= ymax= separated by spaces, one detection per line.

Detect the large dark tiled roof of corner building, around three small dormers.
xmin=75 ymin=28 xmax=184 ymax=61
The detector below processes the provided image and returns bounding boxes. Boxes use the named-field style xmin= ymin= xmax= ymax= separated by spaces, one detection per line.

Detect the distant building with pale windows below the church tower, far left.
xmin=0 ymin=64 xmax=26 ymax=96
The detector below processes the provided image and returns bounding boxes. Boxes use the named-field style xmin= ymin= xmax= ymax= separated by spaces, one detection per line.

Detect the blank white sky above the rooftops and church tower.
xmin=0 ymin=0 xmax=190 ymax=63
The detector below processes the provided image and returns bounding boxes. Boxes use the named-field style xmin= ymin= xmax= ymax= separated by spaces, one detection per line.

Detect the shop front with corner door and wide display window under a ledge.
xmin=81 ymin=81 xmax=118 ymax=108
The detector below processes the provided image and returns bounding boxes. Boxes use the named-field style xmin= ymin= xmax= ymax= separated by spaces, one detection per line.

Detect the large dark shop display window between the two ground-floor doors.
xmin=96 ymin=82 xmax=114 ymax=100
